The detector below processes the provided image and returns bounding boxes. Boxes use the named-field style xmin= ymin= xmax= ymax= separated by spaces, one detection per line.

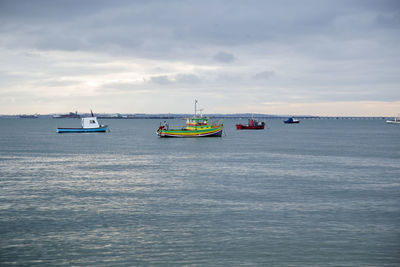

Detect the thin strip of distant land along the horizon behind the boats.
xmin=0 ymin=112 xmax=392 ymax=119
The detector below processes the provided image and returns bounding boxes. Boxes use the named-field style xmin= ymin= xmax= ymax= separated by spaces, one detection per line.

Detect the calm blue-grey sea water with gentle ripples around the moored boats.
xmin=0 ymin=119 xmax=400 ymax=266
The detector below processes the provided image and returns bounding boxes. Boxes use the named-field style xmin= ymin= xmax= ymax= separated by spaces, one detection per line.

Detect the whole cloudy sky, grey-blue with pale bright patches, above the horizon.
xmin=0 ymin=0 xmax=400 ymax=116
